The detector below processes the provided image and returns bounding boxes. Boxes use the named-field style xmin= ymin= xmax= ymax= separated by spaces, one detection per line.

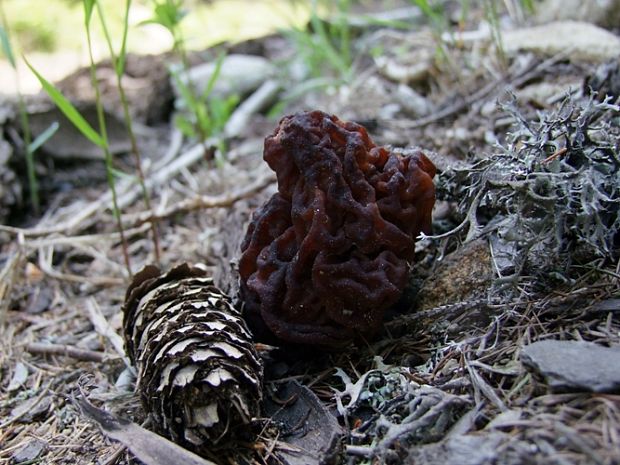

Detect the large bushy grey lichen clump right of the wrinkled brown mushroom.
xmin=438 ymin=96 xmax=620 ymax=283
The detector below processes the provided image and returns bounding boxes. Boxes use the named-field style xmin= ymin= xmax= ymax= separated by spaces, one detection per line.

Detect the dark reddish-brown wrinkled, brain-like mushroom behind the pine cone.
xmin=239 ymin=111 xmax=435 ymax=347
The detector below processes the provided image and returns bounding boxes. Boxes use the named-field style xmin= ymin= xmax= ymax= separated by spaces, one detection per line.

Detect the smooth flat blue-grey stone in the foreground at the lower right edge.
xmin=521 ymin=340 xmax=620 ymax=393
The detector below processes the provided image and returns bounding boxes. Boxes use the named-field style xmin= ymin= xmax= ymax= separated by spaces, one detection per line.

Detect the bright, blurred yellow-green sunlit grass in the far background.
xmin=0 ymin=0 xmax=311 ymax=94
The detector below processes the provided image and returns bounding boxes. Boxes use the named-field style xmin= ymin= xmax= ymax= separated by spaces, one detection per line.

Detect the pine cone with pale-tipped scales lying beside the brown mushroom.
xmin=123 ymin=264 xmax=263 ymax=453
